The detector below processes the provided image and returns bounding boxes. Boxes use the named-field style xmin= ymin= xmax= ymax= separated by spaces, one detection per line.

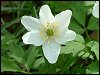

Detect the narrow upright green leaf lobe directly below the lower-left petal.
xmin=25 ymin=46 xmax=38 ymax=70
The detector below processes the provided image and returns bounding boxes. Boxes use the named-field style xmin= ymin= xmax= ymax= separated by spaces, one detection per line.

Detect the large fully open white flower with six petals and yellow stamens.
xmin=21 ymin=5 xmax=76 ymax=64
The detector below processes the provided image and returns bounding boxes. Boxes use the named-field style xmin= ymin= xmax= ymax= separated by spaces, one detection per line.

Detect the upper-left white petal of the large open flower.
xmin=21 ymin=16 xmax=41 ymax=31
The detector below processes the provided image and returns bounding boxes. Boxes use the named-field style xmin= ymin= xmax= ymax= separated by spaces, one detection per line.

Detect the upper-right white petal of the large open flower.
xmin=55 ymin=10 xmax=72 ymax=28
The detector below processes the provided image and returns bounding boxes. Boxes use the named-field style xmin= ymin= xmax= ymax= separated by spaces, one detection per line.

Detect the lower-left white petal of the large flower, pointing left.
xmin=22 ymin=31 xmax=45 ymax=46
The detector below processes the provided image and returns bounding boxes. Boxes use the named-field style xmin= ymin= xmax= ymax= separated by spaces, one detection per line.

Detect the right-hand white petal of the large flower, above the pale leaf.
xmin=55 ymin=30 xmax=76 ymax=44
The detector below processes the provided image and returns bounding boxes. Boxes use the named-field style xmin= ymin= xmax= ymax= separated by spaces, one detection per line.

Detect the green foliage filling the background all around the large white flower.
xmin=1 ymin=1 xmax=99 ymax=74
